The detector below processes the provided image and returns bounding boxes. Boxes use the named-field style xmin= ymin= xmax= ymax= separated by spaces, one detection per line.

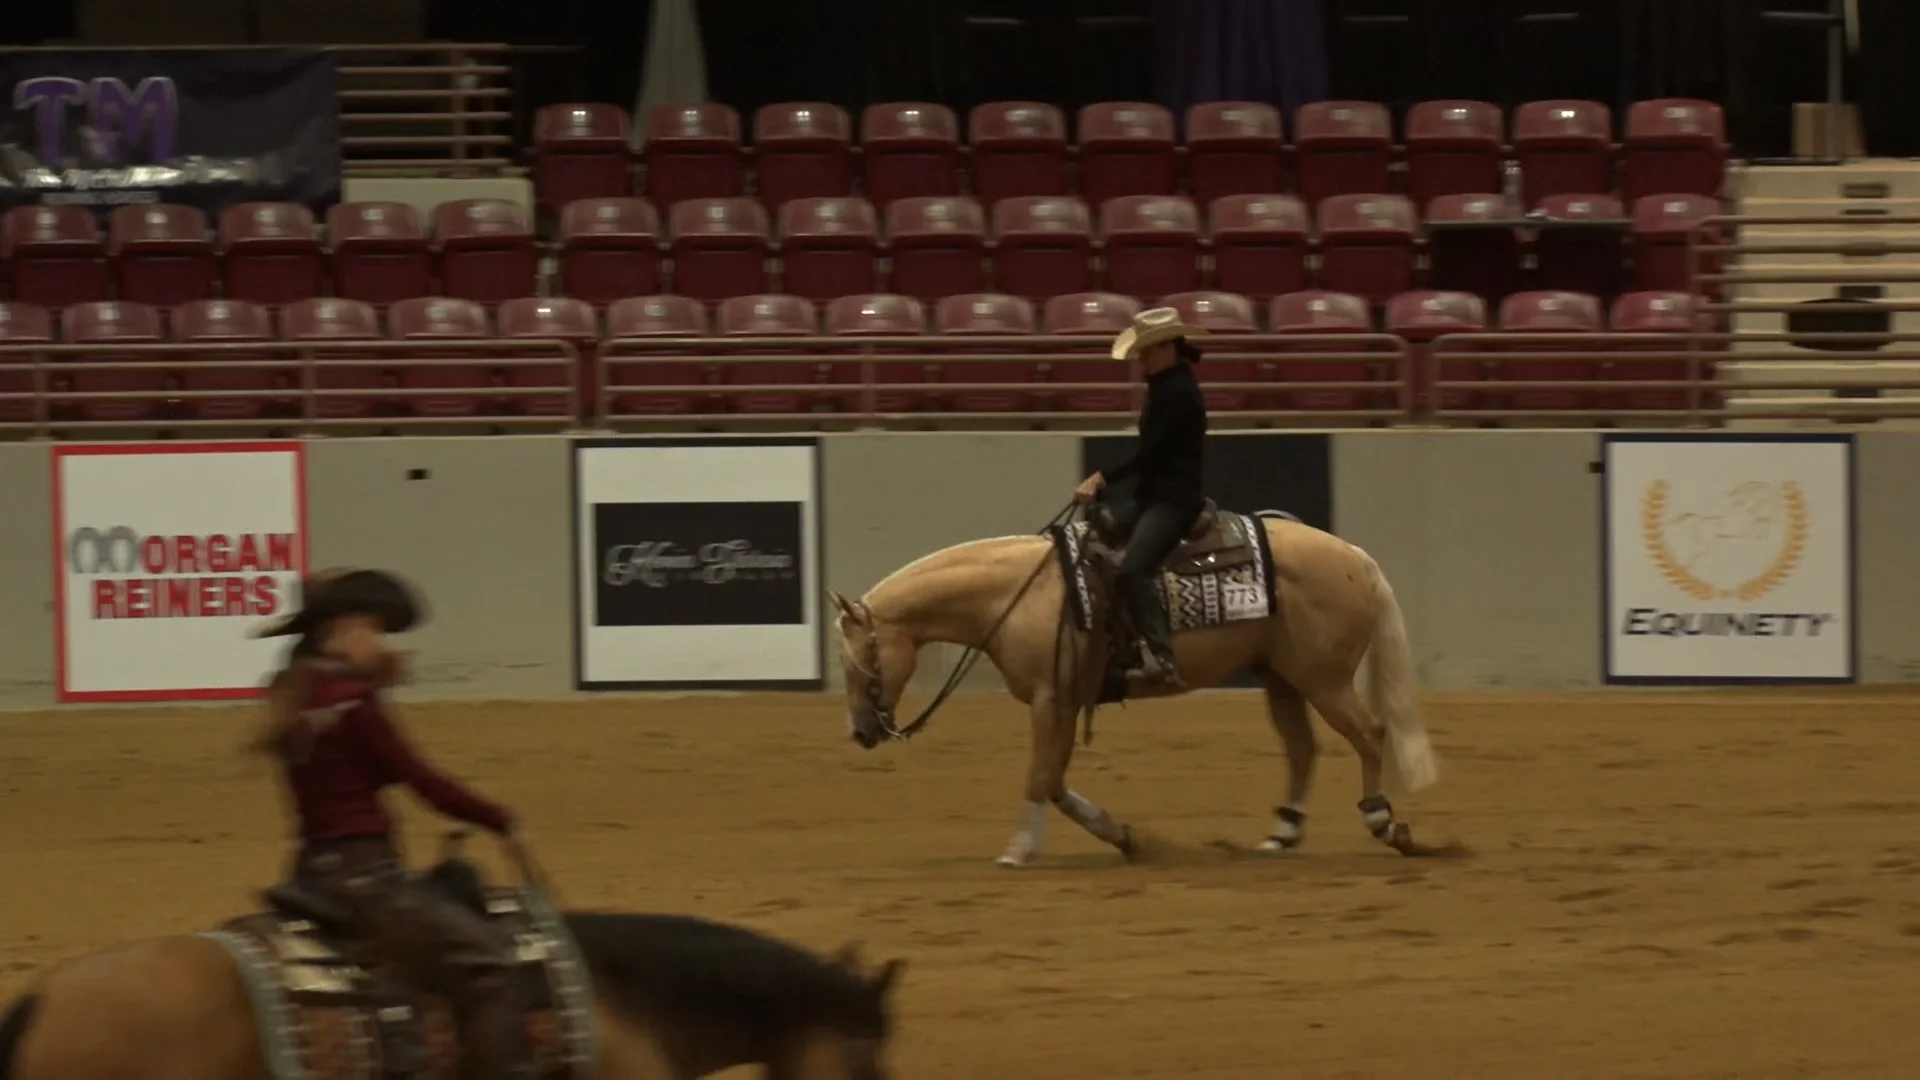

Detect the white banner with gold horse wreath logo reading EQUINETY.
xmin=1601 ymin=434 xmax=1857 ymax=686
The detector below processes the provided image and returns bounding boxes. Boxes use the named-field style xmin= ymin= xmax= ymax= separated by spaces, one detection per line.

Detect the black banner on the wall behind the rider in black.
xmin=1062 ymin=430 xmax=1332 ymax=688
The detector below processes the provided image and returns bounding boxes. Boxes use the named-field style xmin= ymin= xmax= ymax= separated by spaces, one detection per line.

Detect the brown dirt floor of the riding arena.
xmin=0 ymin=692 xmax=1920 ymax=1080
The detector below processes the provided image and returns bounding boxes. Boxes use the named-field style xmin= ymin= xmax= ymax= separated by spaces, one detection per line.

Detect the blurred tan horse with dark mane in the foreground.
xmin=0 ymin=841 xmax=900 ymax=1080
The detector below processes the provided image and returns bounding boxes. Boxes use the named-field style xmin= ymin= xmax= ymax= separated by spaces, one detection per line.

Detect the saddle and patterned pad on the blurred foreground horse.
xmin=207 ymin=836 xmax=593 ymax=1080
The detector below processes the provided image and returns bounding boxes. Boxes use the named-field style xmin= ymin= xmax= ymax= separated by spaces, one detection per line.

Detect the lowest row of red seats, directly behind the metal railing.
xmin=0 ymin=290 xmax=1693 ymax=423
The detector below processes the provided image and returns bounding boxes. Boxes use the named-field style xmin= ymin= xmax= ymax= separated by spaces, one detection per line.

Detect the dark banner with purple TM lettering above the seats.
xmin=0 ymin=48 xmax=340 ymax=219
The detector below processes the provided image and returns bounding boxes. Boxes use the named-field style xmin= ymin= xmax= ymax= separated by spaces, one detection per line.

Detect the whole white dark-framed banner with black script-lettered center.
xmin=572 ymin=438 xmax=824 ymax=690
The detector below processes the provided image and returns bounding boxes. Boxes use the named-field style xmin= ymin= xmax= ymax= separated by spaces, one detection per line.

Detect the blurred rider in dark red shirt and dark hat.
xmin=255 ymin=569 xmax=534 ymax=1080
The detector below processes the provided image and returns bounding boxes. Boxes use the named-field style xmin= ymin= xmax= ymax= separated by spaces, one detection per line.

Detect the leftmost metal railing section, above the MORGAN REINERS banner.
xmin=0 ymin=338 xmax=584 ymax=438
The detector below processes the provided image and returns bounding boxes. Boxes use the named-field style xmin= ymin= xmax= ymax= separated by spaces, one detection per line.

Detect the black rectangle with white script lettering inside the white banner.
xmin=593 ymin=502 xmax=806 ymax=626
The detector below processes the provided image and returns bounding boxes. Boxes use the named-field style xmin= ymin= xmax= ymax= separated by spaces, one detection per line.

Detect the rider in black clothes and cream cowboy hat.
xmin=1073 ymin=307 xmax=1206 ymax=688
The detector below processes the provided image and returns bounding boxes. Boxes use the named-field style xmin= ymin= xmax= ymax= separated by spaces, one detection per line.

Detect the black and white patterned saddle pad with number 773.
xmin=1050 ymin=511 xmax=1277 ymax=634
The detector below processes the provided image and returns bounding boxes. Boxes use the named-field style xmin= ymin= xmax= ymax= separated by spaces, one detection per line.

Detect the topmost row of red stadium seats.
xmin=534 ymin=98 xmax=1728 ymax=209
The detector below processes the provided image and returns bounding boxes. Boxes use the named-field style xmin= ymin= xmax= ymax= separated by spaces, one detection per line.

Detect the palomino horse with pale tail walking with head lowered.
xmin=831 ymin=503 xmax=1438 ymax=867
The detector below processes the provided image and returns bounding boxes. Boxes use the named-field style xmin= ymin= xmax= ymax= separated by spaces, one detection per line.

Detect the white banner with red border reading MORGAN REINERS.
xmin=52 ymin=442 xmax=307 ymax=701
